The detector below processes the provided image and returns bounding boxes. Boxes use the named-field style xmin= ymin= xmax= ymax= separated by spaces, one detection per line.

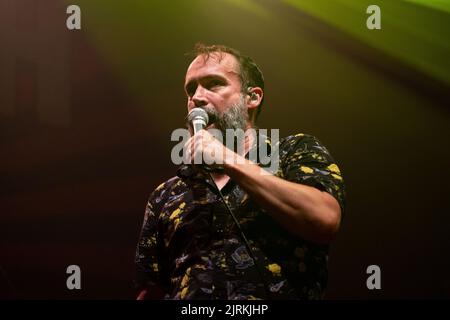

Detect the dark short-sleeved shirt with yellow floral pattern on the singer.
xmin=135 ymin=134 xmax=345 ymax=299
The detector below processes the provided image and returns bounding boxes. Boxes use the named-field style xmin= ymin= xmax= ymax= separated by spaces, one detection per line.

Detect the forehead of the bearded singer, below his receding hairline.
xmin=186 ymin=52 xmax=239 ymax=81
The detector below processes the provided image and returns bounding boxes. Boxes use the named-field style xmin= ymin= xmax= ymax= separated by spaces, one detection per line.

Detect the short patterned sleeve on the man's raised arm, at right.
xmin=280 ymin=133 xmax=345 ymax=215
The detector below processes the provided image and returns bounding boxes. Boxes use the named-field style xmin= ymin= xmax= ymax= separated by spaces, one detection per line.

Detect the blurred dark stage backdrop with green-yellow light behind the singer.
xmin=0 ymin=0 xmax=450 ymax=299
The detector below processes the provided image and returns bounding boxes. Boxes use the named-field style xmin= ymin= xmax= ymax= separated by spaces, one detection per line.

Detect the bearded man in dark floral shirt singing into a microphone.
xmin=136 ymin=45 xmax=344 ymax=299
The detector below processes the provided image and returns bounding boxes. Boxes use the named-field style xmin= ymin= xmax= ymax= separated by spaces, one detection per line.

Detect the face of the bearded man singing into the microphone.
xmin=185 ymin=53 xmax=248 ymax=131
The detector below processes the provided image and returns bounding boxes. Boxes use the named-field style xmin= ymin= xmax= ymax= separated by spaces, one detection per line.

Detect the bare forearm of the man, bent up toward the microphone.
xmin=225 ymin=156 xmax=340 ymax=243
